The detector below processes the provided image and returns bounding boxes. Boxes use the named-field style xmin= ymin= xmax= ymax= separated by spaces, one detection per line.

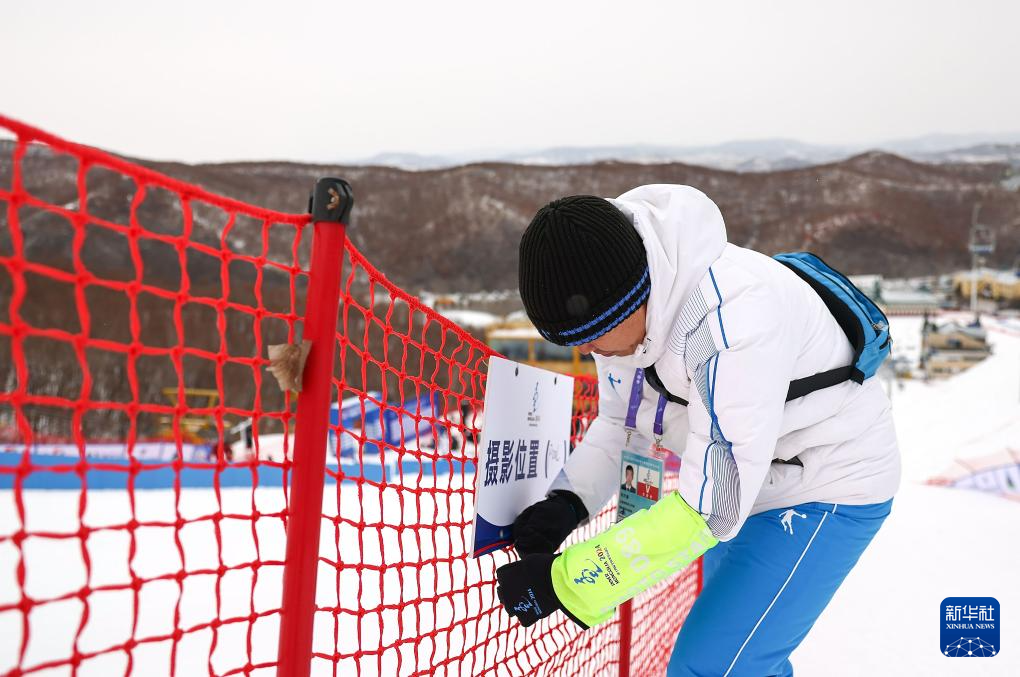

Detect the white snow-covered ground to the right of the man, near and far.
xmin=793 ymin=318 xmax=1020 ymax=677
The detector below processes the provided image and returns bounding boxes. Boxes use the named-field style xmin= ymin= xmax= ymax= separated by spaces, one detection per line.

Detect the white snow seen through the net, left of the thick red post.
xmin=0 ymin=487 xmax=285 ymax=677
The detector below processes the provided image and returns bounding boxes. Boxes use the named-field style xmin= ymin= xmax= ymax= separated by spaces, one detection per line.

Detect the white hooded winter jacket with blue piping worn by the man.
xmin=552 ymin=185 xmax=900 ymax=540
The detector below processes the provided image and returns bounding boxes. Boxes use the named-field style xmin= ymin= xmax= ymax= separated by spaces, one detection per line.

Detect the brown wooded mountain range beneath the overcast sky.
xmin=7 ymin=142 xmax=1020 ymax=292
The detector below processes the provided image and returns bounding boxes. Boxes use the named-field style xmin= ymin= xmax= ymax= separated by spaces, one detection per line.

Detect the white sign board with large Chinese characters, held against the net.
xmin=472 ymin=357 xmax=573 ymax=557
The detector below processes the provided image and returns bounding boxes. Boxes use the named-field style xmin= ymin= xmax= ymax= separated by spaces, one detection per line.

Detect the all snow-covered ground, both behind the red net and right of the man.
xmin=0 ymin=318 xmax=1020 ymax=677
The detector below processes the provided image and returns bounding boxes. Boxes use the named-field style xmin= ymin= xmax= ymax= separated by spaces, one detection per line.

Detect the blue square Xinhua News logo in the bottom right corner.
xmin=938 ymin=597 xmax=1002 ymax=659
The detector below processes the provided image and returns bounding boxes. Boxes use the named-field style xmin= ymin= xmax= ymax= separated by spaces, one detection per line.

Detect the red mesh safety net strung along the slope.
xmin=0 ymin=117 xmax=699 ymax=675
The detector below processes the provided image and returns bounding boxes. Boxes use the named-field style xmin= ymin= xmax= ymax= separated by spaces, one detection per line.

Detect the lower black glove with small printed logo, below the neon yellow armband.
xmin=496 ymin=553 xmax=588 ymax=630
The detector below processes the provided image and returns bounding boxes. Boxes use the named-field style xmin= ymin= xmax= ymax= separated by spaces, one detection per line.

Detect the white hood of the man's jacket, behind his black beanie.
xmin=609 ymin=184 xmax=726 ymax=368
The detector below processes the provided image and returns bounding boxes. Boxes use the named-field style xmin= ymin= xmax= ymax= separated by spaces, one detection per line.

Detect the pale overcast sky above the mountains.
xmin=0 ymin=0 xmax=1020 ymax=161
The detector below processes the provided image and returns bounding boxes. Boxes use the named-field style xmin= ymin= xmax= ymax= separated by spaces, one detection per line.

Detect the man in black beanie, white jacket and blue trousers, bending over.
xmin=497 ymin=186 xmax=900 ymax=677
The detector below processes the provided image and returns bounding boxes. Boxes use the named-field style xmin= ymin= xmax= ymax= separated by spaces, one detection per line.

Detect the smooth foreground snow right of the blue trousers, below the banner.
xmin=792 ymin=483 xmax=1020 ymax=677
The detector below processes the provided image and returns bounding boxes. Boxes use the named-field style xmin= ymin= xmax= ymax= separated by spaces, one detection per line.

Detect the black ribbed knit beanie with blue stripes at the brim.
xmin=518 ymin=195 xmax=651 ymax=346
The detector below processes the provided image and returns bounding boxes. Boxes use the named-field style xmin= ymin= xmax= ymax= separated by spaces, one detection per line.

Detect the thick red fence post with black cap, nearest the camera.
xmin=277 ymin=178 xmax=354 ymax=677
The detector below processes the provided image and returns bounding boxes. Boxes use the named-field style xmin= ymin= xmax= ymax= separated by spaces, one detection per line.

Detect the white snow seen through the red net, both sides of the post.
xmin=0 ymin=475 xmax=485 ymax=677
